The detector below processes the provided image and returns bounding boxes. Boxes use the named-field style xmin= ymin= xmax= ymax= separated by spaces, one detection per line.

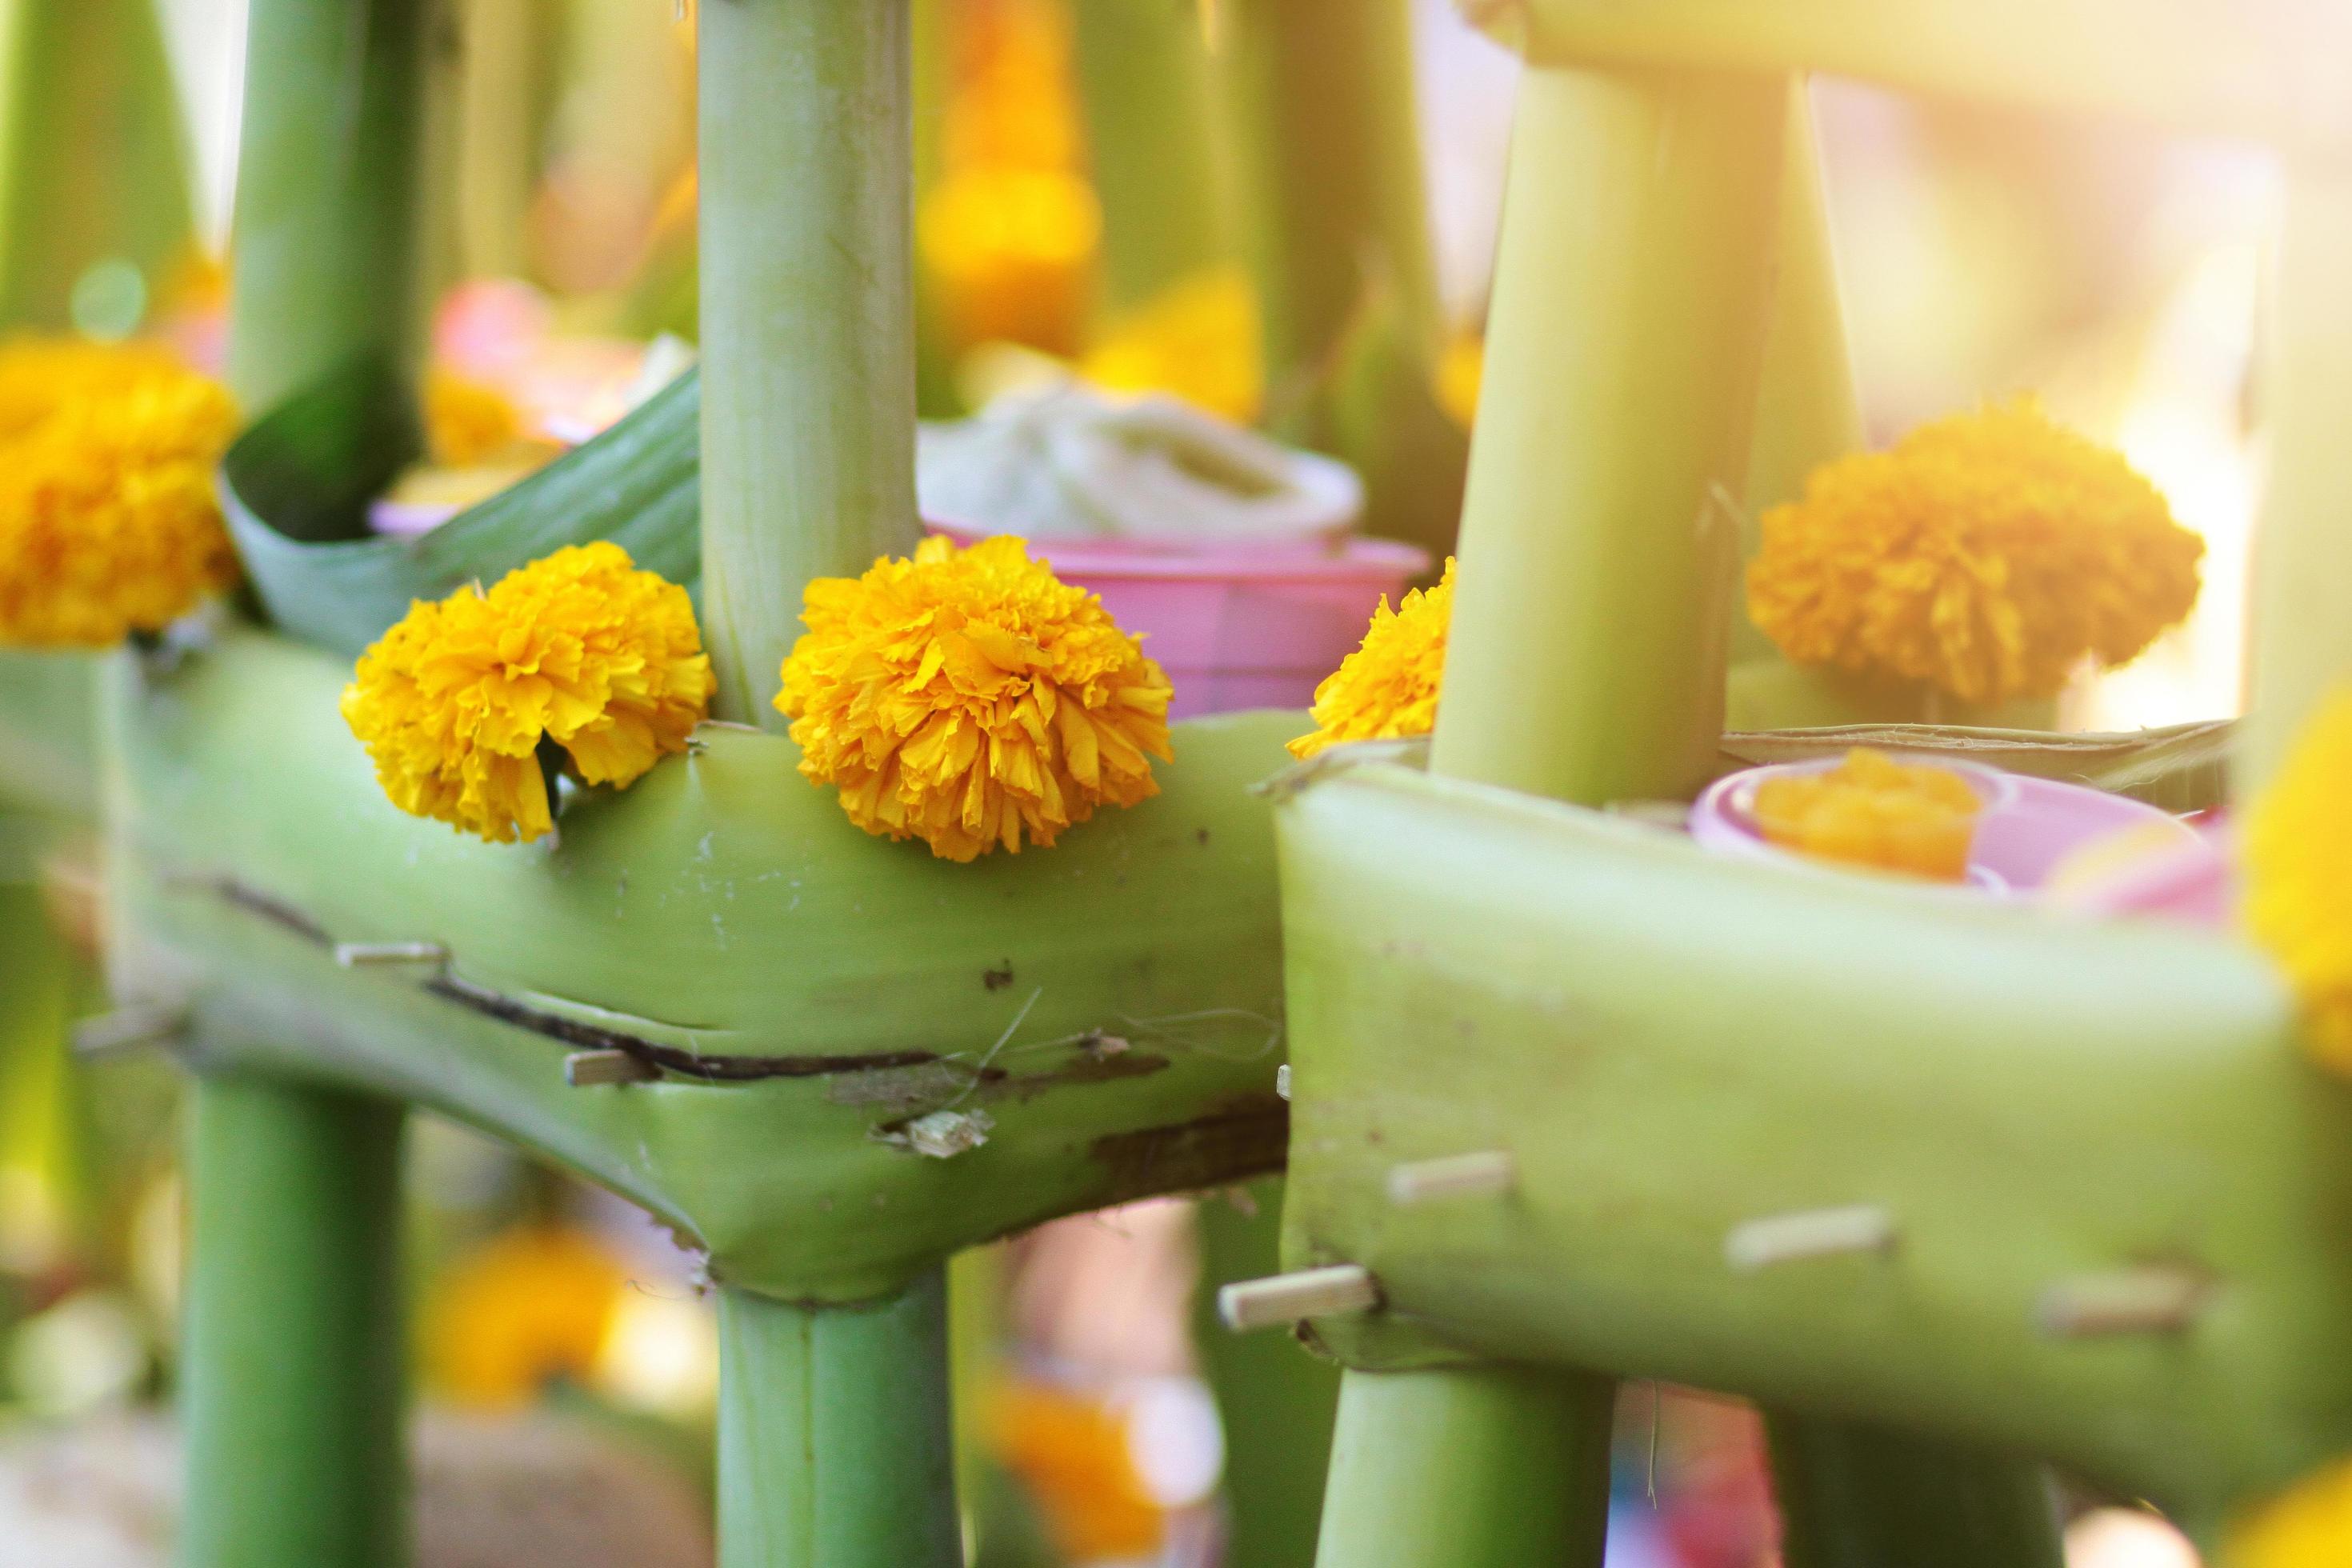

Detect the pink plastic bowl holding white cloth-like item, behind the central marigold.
xmin=931 ymin=522 xmax=1430 ymax=719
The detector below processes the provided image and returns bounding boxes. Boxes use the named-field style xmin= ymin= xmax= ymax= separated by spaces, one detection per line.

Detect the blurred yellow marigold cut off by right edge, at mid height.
xmin=2244 ymin=689 xmax=2352 ymax=1074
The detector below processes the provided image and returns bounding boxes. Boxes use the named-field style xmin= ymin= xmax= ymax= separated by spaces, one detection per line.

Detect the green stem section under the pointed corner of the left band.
xmin=720 ymin=1267 xmax=964 ymax=1568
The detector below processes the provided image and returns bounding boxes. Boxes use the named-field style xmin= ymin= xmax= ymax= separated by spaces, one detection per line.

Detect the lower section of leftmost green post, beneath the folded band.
xmin=178 ymin=1077 xmax=407 ymax=1568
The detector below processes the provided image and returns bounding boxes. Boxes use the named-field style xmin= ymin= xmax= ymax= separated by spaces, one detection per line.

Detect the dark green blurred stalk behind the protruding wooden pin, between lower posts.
xmin=1193 ymin=1175 xmax=1341 ymax=1568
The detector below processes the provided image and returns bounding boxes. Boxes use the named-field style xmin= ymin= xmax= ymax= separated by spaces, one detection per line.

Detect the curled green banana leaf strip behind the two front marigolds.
xmin=221 ymin=360 xmax=701 ymax=656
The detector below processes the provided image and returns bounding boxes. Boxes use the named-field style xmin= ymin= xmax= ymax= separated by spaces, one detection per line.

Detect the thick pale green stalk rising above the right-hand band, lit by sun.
xmin=1430 ymin=70 xmax=1787 ymax=804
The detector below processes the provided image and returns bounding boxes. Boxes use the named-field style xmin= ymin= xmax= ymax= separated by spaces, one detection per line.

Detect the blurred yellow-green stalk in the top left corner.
xmin=0 ymin=0 xmax=195 ymax=331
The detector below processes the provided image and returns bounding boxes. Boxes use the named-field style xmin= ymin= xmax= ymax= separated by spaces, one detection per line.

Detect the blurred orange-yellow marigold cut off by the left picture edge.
xmin=0 ymin=341 xmax=238 ymax=646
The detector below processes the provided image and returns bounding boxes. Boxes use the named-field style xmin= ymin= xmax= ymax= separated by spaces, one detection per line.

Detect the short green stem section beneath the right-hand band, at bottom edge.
xmin=1314 ymin=1366 xmax=1616 ymax=1568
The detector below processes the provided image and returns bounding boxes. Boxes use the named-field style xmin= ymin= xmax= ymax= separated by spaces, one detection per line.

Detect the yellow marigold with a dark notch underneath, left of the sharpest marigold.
xmin=343 ymin=541 xmax=713 ymax=844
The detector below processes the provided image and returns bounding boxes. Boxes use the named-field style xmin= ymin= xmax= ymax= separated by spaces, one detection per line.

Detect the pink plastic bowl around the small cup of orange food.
xmin=1691 ymin=754 xmax=2202 ymax=894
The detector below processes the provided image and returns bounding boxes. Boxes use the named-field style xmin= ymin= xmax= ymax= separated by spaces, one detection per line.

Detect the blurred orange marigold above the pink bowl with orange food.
xmin=1747 ymin=400 xmax=2204 ymax=703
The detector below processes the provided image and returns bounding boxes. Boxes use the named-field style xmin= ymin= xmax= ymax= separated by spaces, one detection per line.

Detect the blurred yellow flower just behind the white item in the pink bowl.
xmin=1079 ymin=266 xmax=1266 ymax=426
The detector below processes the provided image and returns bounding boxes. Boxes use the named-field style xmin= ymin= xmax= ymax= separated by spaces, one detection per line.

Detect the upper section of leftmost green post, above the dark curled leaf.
xmin=228 ymin=0 xmax=433 ymax=416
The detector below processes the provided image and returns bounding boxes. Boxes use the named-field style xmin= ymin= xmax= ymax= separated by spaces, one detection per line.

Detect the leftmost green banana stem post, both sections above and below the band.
xmin=181 ymin=0 xmax=428 ymax=1568
